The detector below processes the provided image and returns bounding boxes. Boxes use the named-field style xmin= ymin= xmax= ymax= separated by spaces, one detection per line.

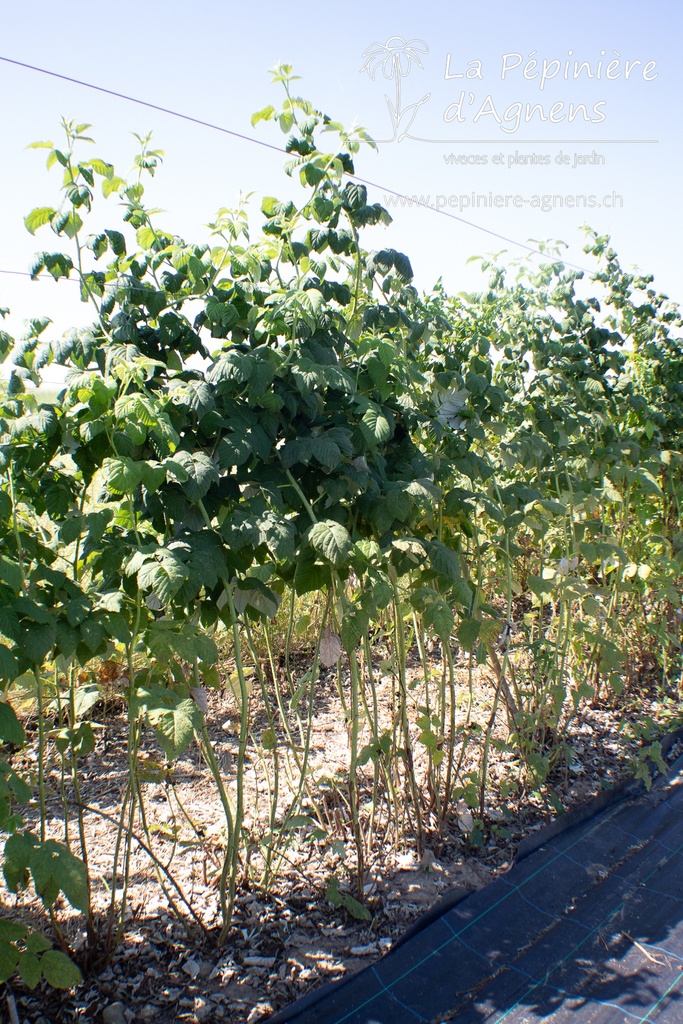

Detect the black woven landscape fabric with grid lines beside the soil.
xmin=275 ymin=758 xmax=683 ymax=1024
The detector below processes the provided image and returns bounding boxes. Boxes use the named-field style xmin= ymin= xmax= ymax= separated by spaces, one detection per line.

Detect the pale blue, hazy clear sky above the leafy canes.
xmin=0 ymin=0 xmax=683 ymax=378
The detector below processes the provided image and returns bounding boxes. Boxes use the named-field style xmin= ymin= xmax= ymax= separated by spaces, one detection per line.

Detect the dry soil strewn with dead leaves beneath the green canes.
xmin=0 ymin=647 xmax=671 ymax=1024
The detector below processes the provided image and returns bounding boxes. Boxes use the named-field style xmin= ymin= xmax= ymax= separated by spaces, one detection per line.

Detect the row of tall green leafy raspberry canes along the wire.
xmin=0 ymin=67 xmax=683 ymax=986
